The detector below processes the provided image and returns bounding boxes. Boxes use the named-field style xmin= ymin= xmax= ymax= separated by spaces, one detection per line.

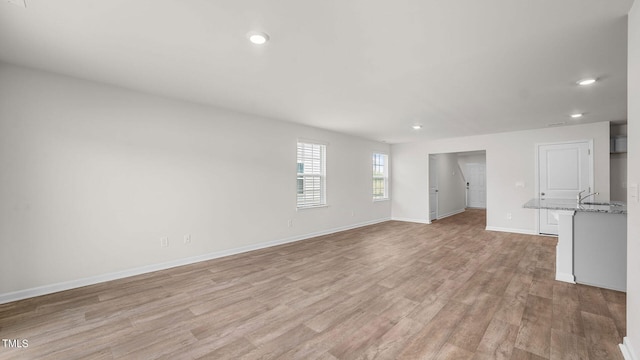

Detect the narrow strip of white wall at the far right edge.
xmin=623 ymin=1 xmax=640 ymax=359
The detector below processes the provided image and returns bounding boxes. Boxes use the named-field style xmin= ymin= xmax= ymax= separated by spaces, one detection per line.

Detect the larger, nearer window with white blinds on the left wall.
xmin=297 ymin=142 xmax=327 ymax=208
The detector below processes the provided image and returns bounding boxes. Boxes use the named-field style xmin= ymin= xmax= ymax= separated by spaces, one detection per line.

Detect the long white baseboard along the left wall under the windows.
xmin=0 ymin=218 xmax=391 ymax=304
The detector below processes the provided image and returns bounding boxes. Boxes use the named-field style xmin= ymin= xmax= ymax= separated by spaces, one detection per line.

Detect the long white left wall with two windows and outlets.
xmin=0 ymin=63 xmax=391 ymax=300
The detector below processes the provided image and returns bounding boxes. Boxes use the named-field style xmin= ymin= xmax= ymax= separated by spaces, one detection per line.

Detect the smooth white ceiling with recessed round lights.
xmin=0 ymin=0 xmax=633 ymax=143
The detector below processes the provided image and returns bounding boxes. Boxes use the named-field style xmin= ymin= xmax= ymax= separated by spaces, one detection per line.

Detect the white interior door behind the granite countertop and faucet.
xmin=538 ymin=141 xmax=593 ymax=235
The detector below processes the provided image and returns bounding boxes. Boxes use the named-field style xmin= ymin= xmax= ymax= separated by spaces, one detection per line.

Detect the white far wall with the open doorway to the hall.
xmin=391 ymin=122 xmax=609 ymax=233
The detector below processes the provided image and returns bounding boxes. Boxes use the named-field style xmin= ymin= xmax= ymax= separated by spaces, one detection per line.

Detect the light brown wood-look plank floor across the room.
xmin=0 ymin=210 xmax=626 ymax=360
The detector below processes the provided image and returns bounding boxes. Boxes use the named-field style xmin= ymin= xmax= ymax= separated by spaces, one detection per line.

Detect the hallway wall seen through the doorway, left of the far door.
xmin=435 ymin=154 xmax=466 ymax=219
